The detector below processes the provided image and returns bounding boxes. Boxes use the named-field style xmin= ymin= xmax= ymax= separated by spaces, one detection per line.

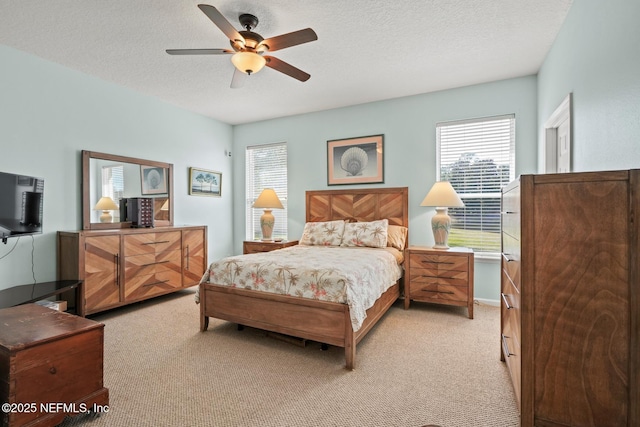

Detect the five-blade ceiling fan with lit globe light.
xmin=167 ymin=4 xmax=318 ymax=88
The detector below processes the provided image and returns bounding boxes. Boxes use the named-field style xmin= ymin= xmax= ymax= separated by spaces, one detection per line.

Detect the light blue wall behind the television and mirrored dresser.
xmin=0 ymin=45 xmax=233 ymax=289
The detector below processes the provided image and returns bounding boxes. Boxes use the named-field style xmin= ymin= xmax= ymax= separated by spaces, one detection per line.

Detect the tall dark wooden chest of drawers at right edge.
xmin=500 ymin=170 xmax=640 ymax=427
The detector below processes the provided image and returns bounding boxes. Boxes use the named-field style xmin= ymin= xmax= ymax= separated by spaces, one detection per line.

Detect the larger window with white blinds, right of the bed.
xmin=436 ymin=114 xmax=515 ymax=255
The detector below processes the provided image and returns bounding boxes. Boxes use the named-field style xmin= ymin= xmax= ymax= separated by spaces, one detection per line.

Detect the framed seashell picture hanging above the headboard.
xmin=327 ymin=135 xmax=384 ymax=185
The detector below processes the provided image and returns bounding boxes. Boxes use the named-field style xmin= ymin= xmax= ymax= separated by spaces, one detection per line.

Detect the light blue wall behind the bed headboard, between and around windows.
xmin=233 ymin=76 xmax=537 ymax=300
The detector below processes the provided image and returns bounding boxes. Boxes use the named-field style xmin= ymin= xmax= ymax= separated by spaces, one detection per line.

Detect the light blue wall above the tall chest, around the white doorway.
xmin=538 ymin=0 xmax=640 ymax=172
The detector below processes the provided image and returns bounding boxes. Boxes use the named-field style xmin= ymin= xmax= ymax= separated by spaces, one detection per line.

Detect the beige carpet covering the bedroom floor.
xmin=58 ymin=290 xmax=519 ymax=427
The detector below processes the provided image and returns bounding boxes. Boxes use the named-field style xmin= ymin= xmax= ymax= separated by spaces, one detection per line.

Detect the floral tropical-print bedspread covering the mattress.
xmin=196 ymin=245 xmax=402 ymax=331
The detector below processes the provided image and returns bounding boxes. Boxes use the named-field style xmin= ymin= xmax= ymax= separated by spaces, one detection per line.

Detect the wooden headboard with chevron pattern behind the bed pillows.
xmin=306 ymin=187 xmax=409 ymax=228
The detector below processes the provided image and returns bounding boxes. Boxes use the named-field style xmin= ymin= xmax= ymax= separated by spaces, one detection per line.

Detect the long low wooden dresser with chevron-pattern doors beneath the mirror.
xmin=58 ymin=226 xmax=208 ymax=316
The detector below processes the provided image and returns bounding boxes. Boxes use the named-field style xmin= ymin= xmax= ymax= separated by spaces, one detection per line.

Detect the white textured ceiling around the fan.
xmin=0 ymin=0 xmax=572 ymax=124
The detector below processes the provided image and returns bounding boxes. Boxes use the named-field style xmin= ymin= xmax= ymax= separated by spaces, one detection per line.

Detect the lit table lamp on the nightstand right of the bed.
xmin=420 ymin=181 xmax=464 ymax=249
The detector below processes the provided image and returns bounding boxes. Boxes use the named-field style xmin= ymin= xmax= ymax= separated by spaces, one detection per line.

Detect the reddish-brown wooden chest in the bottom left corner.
xmin=0 ymin=304 xmax=109 ymax=427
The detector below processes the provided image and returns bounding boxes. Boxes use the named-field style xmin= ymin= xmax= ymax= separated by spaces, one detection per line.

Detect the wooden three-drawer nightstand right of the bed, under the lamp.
xmin=404 ymin=246 xmax=473 ymax=319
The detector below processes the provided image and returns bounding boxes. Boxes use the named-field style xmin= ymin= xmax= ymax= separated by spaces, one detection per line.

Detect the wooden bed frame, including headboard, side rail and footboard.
xmin=200 ymin=187 xmax=409 ymax=369
